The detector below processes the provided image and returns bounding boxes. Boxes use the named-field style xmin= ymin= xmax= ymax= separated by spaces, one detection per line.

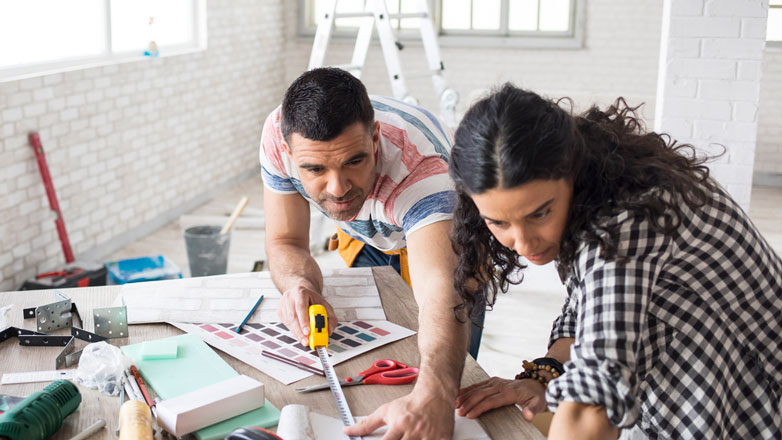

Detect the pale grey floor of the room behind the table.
xmin=111 ymin=176 xmax=782 ymax=377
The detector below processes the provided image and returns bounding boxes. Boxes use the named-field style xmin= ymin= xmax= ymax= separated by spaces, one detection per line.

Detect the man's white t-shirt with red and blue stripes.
xmin=260 ymin=96 xmax=456 ymax=251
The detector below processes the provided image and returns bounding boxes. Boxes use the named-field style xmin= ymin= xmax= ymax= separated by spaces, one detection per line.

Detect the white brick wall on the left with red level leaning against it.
xmin=0 ymin=0 xmax=285 ymax=291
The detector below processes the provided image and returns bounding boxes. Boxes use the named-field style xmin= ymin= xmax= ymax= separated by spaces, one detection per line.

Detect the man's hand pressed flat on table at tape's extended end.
xmin=344 ymin=390 xmax=454 ymax=440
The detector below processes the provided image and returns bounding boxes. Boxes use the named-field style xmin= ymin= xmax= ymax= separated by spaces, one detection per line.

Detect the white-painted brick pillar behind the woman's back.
xmin=655 ymin=0 xmax=768 ymax=209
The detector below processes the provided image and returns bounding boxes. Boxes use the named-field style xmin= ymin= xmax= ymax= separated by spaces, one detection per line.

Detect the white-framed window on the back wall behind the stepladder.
xmin=299 ymin=0 xmax=580 ymax=47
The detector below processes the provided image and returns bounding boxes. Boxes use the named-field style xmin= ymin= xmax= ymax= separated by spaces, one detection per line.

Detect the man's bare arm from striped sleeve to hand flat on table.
xmin=345 ymin=221 xmax=469 ymax=440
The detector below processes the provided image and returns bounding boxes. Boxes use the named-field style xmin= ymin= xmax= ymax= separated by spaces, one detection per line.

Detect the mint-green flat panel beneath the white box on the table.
xmin=122 ymin=334 xmax=280 ymax=440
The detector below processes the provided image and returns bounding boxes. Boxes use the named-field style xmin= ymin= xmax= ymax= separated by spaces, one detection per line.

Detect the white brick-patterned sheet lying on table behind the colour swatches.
xmin=114 ymin=267 xmax=386 ymax=324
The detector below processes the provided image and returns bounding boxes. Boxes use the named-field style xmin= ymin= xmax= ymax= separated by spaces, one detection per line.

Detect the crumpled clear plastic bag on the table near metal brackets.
xmin=74 ymin=341 xmax=130 ymax=396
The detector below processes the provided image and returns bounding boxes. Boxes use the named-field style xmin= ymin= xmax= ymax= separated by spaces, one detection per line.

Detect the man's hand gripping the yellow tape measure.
xmin=277 ymin=285 xmax=338 ymax=347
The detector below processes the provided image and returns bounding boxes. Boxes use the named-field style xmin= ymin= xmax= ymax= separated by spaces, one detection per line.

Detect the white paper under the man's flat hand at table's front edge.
xmin=277 ymin=404 xmax=490 ymax=440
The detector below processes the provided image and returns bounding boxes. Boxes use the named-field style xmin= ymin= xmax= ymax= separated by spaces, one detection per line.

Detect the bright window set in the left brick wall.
xmin=0 ymin=0 xmax=206 ymax=80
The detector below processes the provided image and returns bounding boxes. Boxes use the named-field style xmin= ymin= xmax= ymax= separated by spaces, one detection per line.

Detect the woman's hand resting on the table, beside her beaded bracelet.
xmin=456 ymin=377 xmax=546 ymax=420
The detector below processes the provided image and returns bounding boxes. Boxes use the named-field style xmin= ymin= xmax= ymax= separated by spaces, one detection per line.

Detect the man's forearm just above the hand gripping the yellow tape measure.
xmin=266 ymin=243 xmax=323 ymax=292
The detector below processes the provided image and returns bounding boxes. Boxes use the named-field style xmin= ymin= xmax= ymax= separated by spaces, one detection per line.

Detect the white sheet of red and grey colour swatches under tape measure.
xmin=171 ymin=320 xmax=415 ymax=385
